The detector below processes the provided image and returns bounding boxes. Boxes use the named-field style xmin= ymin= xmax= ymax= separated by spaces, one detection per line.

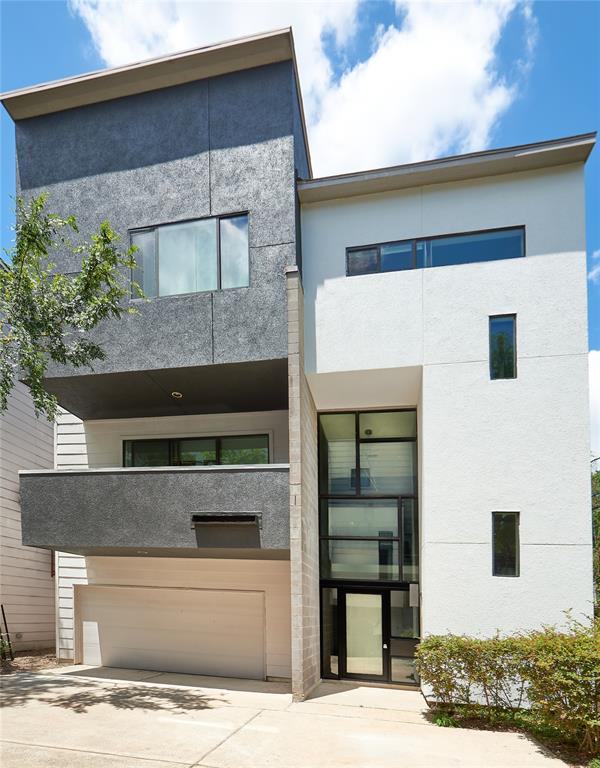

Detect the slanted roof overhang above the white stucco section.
xmin=298 ymin=132 xmax=596 ymax=203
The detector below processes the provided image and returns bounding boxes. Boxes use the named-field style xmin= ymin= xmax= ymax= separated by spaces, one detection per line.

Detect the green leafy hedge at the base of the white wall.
xmin=417 ymin=619 xmax=600 ymax=755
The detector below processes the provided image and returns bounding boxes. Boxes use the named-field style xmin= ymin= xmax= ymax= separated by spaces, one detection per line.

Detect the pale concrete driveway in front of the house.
xmin=0 ymin=667 xmax=564 ymax=768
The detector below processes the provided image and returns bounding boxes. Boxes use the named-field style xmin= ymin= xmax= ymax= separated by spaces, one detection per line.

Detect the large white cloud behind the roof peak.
xmin=69 ymin=0 xmax=537 ymax=175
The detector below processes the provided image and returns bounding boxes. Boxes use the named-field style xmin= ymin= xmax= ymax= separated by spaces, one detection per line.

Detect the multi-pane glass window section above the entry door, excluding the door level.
xmin=319 ymin=409 xmax=419 ymax=583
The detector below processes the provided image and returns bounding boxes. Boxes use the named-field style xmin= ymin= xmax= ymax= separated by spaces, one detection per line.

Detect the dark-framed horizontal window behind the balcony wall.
xmin=123 ymin=435 xmax=269 ymax=467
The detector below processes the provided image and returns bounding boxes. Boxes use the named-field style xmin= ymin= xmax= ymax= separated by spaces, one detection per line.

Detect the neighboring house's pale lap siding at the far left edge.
xmin=0 ymin=383 xmax=54 ymax=650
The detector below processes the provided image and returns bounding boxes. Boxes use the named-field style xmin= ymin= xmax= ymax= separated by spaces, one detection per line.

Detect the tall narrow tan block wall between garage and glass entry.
xmin=287 ymin=267 xmax=321 ymax=699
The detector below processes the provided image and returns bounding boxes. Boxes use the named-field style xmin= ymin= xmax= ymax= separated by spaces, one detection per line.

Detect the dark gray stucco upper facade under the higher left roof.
xmin=16 ymin=60 xmax=308 ymax=418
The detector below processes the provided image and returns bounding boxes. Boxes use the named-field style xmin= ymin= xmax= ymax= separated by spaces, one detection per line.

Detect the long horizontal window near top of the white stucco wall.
xmin=346 ymin=227 xmax=525 ymax=276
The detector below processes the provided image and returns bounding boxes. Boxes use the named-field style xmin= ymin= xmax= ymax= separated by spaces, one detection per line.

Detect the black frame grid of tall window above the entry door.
xmin=317 ymin=408 xmax=421 ymax=589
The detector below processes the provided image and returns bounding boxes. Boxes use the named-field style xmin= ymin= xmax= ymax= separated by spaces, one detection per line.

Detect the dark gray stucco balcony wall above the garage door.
xmin=20 ymin=468 xmax=289 ymax=551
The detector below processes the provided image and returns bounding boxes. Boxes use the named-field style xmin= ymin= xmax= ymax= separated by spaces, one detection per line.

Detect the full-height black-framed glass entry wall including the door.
xmin=319 ymin=410 xmax=419 ymax=683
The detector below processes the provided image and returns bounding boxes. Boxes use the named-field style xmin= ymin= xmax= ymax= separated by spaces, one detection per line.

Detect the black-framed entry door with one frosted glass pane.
xmin=340 ymin=590 xmax=389 ymax=680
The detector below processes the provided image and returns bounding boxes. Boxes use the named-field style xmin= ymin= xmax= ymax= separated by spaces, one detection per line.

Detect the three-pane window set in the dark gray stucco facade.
xmin=131 ymin=214 xmax=250 ymax=297
